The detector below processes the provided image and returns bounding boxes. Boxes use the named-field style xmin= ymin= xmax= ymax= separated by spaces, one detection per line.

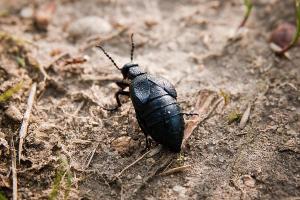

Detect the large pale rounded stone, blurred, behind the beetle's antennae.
xmin=68 ymin=16 xmax=112 ymax=41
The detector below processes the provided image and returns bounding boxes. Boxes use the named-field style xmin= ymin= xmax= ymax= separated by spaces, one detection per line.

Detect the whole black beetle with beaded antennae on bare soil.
xmin=97 ymin=35 xmax=184 ymax=152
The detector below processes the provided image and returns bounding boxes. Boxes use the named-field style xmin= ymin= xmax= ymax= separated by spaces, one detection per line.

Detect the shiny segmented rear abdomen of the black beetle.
xmin=139 ymin=95 xmax=184 ymax=152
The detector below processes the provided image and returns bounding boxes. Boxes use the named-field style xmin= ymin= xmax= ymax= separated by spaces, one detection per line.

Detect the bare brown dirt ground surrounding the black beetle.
xmin=0 ymin=0 xmax=300 ymax=200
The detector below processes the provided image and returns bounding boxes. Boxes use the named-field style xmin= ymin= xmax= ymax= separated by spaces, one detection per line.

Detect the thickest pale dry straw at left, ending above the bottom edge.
xmin=18 ymin=83 xmax=37 ymax=162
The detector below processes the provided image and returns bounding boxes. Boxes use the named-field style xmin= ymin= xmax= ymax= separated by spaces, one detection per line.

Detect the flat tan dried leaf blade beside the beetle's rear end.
xmin=182 ymin=91 xmax=223 ymax=146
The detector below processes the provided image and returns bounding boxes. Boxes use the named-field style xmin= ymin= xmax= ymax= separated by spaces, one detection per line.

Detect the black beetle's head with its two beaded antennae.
xmin=97 ymin=34 xmax=145 ymax=79
